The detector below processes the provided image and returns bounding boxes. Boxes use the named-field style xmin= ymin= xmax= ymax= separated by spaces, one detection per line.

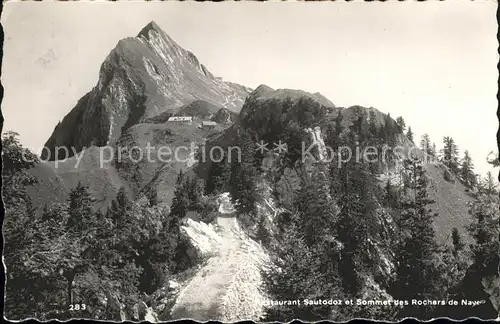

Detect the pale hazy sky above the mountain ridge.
xmin=1 ymin=0 xmax=498 ymax=177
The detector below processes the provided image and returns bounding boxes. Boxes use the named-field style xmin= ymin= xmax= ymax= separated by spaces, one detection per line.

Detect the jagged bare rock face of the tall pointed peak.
xmin=42 ymin=22 xmax=250 ymax=159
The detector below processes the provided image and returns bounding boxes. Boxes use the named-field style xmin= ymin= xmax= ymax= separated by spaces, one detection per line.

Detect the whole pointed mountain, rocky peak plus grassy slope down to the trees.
xmin=28 ymin=22 xmax=250 ymax=208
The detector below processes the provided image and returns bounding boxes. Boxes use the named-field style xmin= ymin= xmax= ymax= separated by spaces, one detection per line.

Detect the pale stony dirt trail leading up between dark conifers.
xmin=171 ymin=195 xmax=267 ymax=322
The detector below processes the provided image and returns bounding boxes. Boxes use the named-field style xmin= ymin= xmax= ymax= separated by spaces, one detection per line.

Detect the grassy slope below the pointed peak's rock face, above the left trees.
xmin=28 ymin=123 xmax=227 ymax=208
